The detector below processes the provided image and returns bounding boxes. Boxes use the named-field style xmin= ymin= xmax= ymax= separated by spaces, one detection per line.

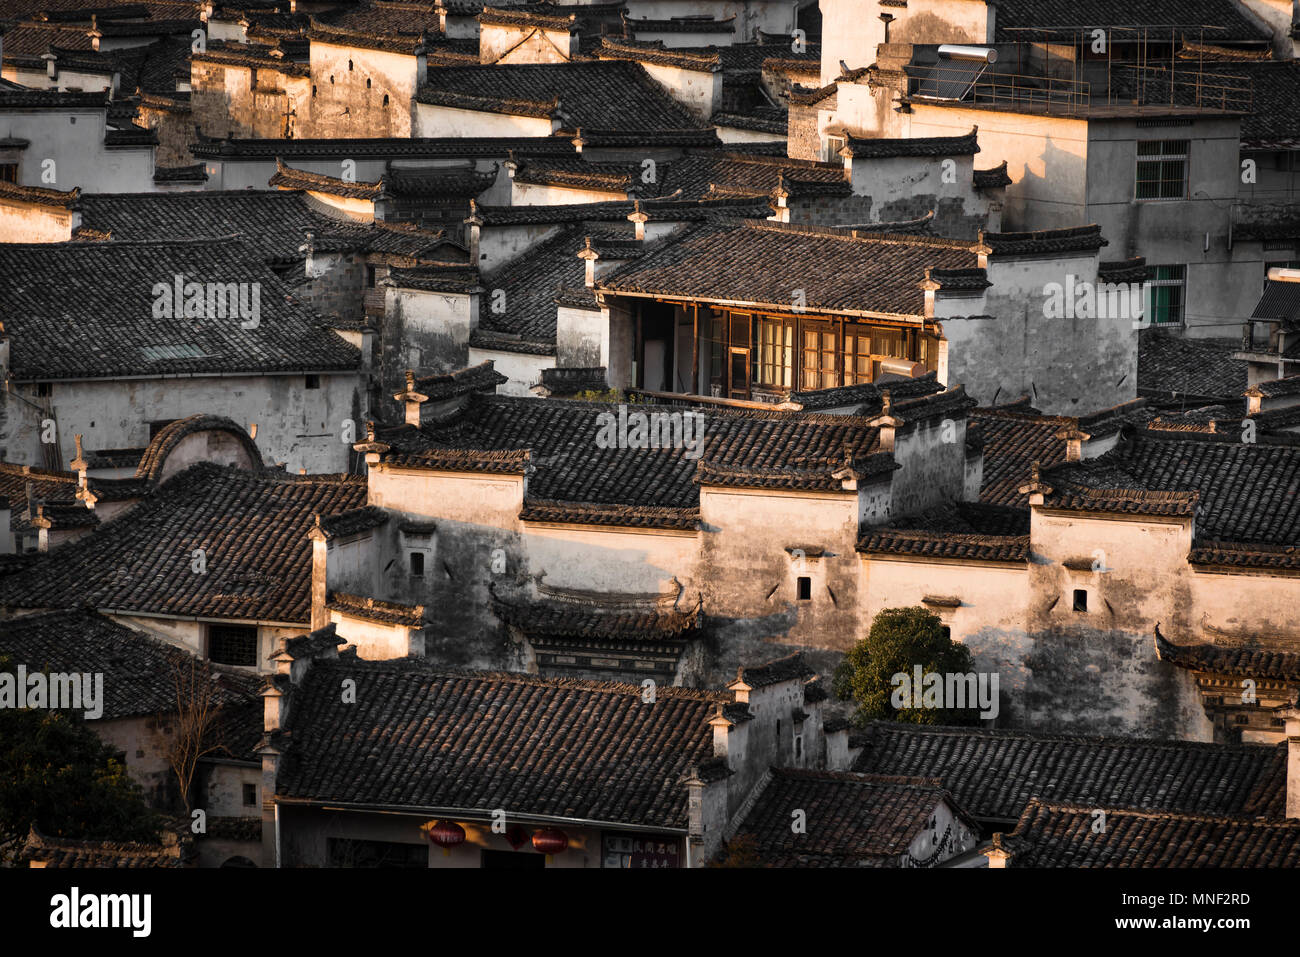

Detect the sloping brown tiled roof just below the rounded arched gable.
xmin=0 ymin=463 xmax=365 ymax=623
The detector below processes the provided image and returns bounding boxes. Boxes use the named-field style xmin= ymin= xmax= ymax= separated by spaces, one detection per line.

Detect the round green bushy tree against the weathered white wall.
xmin=832 ymin=607 xmax=979 ymax=726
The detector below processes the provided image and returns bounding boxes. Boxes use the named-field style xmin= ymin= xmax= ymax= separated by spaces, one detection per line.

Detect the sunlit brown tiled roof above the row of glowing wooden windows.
xmin=597 ymin=222 xmax=978 ymax=316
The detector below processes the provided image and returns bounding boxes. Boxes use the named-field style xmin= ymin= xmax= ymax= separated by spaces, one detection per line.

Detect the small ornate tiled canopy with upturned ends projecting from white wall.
xmin=491 ymin=586 xmax=701 ymax=641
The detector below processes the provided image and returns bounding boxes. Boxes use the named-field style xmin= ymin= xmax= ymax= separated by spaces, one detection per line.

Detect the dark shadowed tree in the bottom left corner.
xmin=0 ymin=661 xmax=160 ymax=858
